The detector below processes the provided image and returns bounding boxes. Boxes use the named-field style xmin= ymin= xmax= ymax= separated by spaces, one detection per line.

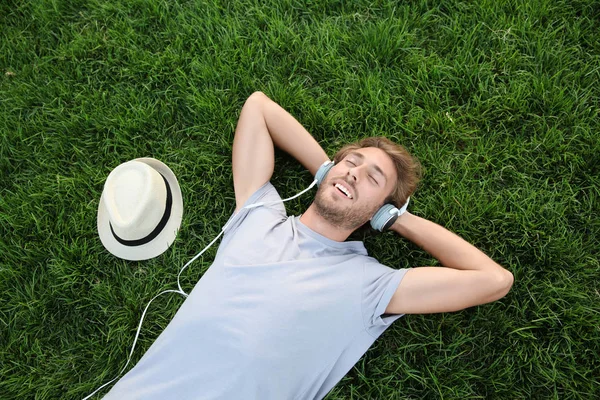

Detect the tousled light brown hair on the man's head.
xmin=333 ymin=136 xmax=421 ymax=207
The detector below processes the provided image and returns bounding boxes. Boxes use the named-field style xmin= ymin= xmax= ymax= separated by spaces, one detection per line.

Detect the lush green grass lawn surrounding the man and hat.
xmin=0 ymin=0 xmax=600 ymax=400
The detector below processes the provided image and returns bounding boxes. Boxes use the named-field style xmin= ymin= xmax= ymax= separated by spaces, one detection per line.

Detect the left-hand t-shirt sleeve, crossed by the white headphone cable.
xmin=223 ymin=182 xmax=287 ymax=238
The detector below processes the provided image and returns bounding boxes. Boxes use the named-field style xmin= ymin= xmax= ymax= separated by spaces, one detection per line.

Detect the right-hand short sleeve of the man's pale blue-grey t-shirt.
xmin=362 ymin=257 xmax=408 ymax=338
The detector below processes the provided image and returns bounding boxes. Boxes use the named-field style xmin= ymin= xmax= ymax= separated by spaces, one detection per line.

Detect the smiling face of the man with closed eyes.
xmin=314 ymin=147 xmax=397 ymax=230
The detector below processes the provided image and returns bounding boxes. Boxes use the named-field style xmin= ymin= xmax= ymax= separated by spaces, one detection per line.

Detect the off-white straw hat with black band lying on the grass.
xmin=98 ymin=158 xmax=183 ymax=261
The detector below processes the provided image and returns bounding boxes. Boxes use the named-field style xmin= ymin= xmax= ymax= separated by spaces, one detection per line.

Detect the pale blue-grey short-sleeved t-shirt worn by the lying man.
xmin=105 ymin=182 xmax=407 ymax=400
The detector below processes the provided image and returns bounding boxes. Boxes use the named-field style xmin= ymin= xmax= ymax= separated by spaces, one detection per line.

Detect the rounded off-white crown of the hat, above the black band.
xmin=104 ymin=161 xmax=167 ymax=240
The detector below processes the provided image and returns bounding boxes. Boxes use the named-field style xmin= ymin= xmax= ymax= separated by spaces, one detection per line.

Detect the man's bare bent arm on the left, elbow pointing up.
xmin=232 ymin=92 xmax=329 ymax=212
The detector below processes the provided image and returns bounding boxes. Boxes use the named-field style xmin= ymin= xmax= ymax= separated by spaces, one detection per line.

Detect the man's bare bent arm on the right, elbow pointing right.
xmin=386 ymin=212 xmax=514 ymax=314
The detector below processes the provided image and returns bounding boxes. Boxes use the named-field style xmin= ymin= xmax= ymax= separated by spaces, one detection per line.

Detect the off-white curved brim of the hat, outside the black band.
xmin=98 ymin=158 xmax=183 ymax=261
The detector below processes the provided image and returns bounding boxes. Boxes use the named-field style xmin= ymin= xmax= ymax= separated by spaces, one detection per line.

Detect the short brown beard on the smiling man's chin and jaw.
xmin=313 ymin=181 xmax=376 ymax=231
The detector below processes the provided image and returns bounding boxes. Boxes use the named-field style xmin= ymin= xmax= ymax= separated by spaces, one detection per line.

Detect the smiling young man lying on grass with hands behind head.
xmin=106 ymin=92 xmax=513 ymax=400
